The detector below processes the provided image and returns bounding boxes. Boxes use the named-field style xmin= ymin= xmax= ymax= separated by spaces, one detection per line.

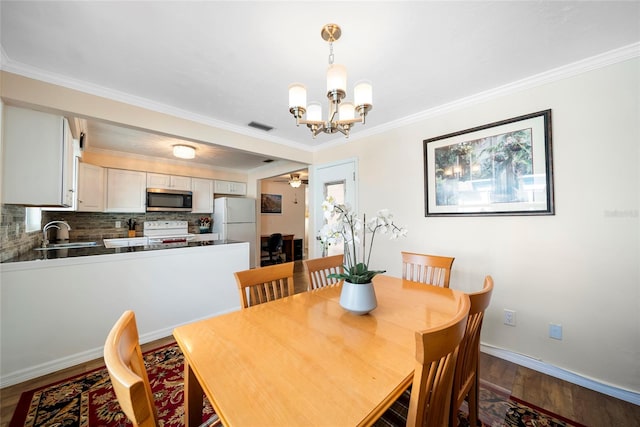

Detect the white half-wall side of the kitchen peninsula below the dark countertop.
xmin=0 ymin=241 xmax=249 ymax=387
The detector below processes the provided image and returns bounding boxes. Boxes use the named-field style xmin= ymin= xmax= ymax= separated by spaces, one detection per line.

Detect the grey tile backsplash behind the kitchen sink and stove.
xmin=0 ymin=205 xmax=211 ymax=262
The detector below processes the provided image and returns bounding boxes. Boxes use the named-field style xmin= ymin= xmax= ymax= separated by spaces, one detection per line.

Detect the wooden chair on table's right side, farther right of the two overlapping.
xmin=449 ymin=276 xmax=493 ymax=427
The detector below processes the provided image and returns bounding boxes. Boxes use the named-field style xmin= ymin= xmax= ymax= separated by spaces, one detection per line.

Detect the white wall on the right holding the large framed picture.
xmin=314 ymin=59 xmax=640 ymax=392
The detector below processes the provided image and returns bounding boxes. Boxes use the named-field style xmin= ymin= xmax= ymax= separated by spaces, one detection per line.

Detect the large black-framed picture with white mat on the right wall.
xmin=424 ymin=110 xmax=555 ymax=216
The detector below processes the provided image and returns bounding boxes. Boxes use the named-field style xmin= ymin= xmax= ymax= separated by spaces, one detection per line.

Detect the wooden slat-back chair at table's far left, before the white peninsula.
xmin=233 ymin=262 xmax=294 ymax=308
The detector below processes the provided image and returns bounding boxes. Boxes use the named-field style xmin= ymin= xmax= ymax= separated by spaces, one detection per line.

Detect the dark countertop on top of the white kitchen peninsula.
xmin=2 ymin=240 xmax=241 ymax=264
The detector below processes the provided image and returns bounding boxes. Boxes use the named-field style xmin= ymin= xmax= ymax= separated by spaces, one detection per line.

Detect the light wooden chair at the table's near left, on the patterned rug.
xmin=104 ymin=310 xmax=222 ymax=427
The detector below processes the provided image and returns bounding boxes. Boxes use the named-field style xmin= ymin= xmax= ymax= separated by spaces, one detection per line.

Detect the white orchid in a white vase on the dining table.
xmin=320 ymin=196 xmax=407 ymax=314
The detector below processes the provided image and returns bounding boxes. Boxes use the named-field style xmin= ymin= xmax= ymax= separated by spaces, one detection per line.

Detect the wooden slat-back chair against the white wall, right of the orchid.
xmin=402 ymin=252 xmax=455 ymax=288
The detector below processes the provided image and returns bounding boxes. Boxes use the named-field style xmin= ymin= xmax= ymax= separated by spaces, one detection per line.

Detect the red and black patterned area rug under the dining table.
xmin=9 ymin=344 xmax=584 ymax=427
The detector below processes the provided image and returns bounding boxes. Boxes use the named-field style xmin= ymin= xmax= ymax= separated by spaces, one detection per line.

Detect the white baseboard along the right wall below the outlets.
xmin=480 ymin=344 xmax=640 ymax=405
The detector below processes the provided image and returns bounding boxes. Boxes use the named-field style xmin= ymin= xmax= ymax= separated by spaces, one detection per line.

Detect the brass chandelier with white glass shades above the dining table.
xmin=289 ymin=24 xmax=373 ymax=138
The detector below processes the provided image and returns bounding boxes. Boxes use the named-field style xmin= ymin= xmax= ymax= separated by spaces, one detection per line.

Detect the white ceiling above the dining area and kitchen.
xmin=0 ymin=0 xmax=640 ymax=170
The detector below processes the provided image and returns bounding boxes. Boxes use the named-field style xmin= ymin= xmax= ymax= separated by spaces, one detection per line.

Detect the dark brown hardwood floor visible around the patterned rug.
xmin=0 ymin=261 xmax=640 ymax=427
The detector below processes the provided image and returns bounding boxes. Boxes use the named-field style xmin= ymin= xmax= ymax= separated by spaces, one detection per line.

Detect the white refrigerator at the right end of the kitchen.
xmin=212 ymin=197 xmax=257 ymax=268
